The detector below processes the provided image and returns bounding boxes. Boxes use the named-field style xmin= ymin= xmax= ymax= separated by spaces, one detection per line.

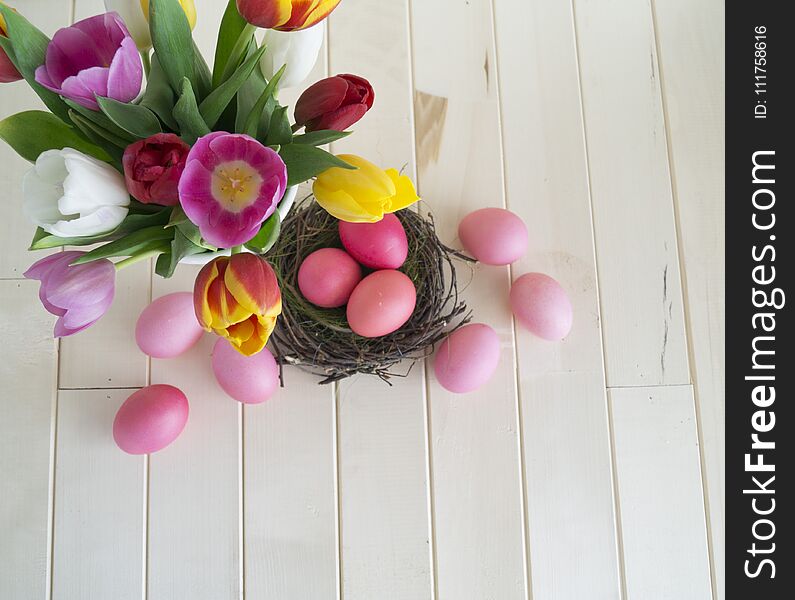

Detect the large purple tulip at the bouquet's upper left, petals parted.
xmin=36 ymin=12 xmax=144 ymax=110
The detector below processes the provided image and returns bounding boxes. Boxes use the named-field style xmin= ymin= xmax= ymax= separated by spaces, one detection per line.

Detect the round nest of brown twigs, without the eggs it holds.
xmin=268 ymin=197 xmax=472 ymax=383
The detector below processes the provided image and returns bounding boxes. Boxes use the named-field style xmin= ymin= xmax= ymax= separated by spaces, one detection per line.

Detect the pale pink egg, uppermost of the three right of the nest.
xmin=458 ymin=208 xmax=527 ymax=265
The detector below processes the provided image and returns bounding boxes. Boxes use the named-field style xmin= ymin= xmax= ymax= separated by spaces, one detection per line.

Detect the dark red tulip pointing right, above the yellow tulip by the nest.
xmin=295 ymin=75 xmax=375 ymax=131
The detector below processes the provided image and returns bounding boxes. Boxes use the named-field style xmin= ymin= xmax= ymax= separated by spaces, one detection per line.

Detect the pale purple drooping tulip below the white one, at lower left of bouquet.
xmin=25 ymin=250 xmax=116 ymax=337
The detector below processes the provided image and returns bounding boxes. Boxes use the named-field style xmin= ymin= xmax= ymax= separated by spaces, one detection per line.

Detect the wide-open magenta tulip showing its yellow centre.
xmin=179 ymin=131 xmax=287 ymax=248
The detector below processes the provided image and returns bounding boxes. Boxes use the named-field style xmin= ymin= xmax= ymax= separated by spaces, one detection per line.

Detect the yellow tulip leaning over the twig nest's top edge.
xmin=312 ymin=154 xmax=419 ymax=223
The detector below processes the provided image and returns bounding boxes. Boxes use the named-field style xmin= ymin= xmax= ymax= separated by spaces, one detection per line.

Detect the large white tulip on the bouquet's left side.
xmin=22 ymin=148 xmax=130 ymax=237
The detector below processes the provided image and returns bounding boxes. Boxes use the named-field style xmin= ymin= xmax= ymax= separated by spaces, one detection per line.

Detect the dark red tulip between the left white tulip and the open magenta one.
xmin=122 ymin=133 xmax=190 ymax=206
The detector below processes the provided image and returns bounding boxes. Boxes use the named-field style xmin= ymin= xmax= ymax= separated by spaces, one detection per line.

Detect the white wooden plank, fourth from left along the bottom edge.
xmin=243 ymin=24 xmax=339 ymax=600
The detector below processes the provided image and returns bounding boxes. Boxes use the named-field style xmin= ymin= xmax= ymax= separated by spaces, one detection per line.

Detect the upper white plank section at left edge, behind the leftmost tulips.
xmin=0 ymin=0 xmax=71 ymax=279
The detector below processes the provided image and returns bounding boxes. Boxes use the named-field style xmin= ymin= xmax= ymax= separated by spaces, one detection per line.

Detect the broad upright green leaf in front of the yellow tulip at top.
xmin=149 ymin=0 xmax=199 ymax=92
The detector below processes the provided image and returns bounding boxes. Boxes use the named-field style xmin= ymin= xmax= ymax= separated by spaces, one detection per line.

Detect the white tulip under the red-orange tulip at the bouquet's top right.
xmin=260 ymin=22 xmax=326 ymax=88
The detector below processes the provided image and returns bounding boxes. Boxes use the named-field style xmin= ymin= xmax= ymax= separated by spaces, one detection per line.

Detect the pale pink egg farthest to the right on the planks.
xmin=511 ymin=273 xmax=574 ymax=341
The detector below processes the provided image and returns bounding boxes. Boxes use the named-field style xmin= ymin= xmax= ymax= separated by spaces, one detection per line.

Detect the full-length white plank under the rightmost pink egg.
xmin=495 ymin=0 xmax=620 ymax=600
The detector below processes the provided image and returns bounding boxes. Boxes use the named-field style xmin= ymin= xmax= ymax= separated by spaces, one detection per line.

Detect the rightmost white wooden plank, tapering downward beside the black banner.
xmin=653 ymin=0 xmax=726 ymax=600
